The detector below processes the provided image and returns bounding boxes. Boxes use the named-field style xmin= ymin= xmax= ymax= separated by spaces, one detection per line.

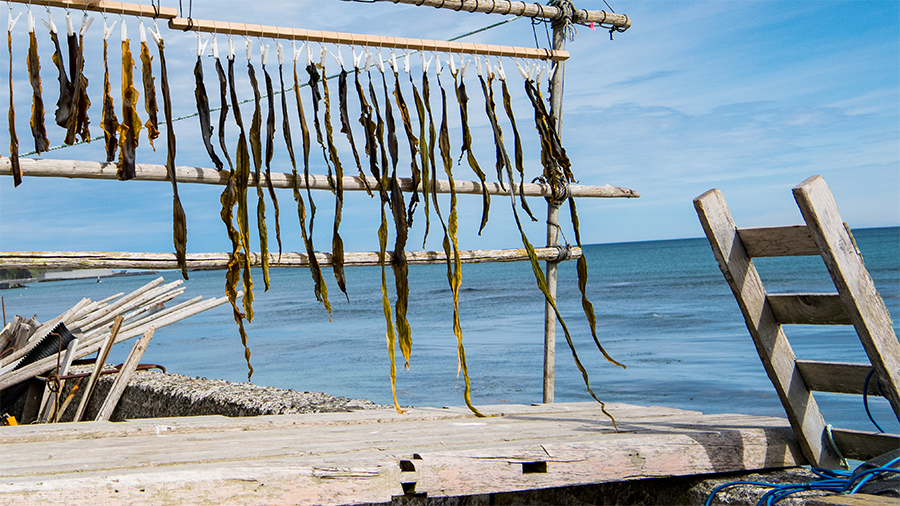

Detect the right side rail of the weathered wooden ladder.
xmin=793 ymin=176 xmax=900 ymax=418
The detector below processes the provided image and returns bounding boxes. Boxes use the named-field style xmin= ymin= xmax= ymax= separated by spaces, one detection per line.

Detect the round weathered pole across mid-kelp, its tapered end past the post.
xmin=0 ymin=157 xmax=641 ymax=198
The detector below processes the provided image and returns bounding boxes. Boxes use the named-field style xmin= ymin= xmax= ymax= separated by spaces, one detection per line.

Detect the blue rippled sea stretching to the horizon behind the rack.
xmin=0 ymin=227 xmax=900 ymax=433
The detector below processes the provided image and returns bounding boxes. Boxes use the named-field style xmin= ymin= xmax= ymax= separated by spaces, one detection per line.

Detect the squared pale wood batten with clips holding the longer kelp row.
xmin=169 ymin=18 xmax=569 ymax=60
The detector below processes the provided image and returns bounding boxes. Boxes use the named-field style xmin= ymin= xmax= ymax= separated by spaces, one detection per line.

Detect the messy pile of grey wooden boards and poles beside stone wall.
xmin=0 ymin=277 xmax=228 ymax=422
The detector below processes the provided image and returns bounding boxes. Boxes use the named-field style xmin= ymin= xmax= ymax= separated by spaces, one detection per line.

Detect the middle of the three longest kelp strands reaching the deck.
xmin=435 ymin=64 xmax=484 ymax=416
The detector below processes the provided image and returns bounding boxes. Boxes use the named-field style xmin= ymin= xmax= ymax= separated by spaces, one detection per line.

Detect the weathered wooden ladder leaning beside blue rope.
xmin=694 ymin=176 xmax=900 ymax=469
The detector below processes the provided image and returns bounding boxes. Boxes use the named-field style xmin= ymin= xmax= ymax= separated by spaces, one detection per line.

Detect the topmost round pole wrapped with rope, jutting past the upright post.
xmin=361 ymin=0 xmax=631 ymax=31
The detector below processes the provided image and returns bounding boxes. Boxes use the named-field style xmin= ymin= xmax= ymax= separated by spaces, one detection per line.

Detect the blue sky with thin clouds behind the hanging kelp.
xmin=0 ymin=0 xmax=900 ymax=253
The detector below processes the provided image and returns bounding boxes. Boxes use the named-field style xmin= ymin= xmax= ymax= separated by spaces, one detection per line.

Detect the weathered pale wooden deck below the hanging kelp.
xmin=0 ymin=403 xmax=804 ymax=506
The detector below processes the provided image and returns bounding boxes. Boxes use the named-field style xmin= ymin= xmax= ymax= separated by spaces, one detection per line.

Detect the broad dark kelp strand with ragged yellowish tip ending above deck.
xmin=379 ymin=62 xmax=412 ymax=369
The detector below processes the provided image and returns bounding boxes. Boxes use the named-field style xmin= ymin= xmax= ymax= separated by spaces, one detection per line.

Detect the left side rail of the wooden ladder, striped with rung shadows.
xmin=694 ymin=190 xmax=841 ymax=468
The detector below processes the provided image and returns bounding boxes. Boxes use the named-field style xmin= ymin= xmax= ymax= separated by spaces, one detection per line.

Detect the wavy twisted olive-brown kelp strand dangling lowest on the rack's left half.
xmin=213 ymin=38 xmax=252 ymax=379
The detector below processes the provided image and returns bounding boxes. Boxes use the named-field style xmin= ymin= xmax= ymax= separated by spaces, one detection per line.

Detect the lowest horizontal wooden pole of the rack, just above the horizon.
xmin=0 ymin=247 xmax=582 ymax=269
